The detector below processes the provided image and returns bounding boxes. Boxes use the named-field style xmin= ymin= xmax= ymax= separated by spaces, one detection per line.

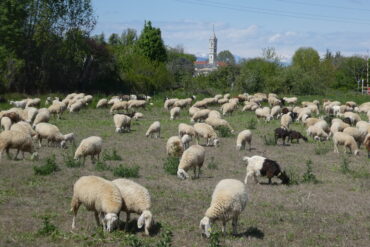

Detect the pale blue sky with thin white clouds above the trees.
xmin=92 ymin=0 xmax=370 ymax=61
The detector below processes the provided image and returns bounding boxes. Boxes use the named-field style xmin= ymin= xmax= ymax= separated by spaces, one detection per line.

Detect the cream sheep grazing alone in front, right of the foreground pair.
xmin=199 ymin=179 xmax=248 ymax=238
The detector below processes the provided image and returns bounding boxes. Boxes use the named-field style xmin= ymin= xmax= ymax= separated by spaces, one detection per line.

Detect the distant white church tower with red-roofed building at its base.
xmin=194 ymin=28 xmax=226 ymax=76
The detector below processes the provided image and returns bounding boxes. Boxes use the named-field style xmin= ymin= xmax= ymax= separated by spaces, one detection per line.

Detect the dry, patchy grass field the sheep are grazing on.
xmin=0 ymin=93 xmax=370 ymax=247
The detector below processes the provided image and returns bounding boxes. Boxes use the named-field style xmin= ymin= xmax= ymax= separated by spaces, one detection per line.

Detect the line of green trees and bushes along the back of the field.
xmin=0 ymin=0 xmax=368 ymax=95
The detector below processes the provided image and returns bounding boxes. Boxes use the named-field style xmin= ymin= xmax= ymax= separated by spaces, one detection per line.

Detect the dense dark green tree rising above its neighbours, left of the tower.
xmin=137 ymin=21 xmax=167 ymax=62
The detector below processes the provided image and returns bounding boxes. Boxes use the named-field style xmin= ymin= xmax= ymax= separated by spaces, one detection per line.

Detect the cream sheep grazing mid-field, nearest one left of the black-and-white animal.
xmin=177 ymin=145 xmax=206 ymax=179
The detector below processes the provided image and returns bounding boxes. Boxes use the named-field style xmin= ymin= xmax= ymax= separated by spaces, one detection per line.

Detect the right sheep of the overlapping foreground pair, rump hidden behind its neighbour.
xmin=112 ymin=178 xmax=154 ymax=235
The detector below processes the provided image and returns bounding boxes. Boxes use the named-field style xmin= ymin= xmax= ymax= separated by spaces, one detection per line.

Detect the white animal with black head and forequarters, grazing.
xmin=243 ymin=155 xmax=290 ymax=184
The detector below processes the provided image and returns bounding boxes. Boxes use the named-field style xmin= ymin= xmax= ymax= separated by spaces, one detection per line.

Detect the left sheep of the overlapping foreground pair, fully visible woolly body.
xmin=71 ymin=176 xmax=123 ymax=232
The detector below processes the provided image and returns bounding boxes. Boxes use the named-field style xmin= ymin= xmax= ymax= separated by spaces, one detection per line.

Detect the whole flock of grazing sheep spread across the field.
xmin=0 ymin=93 xmax=370 ymax=237
